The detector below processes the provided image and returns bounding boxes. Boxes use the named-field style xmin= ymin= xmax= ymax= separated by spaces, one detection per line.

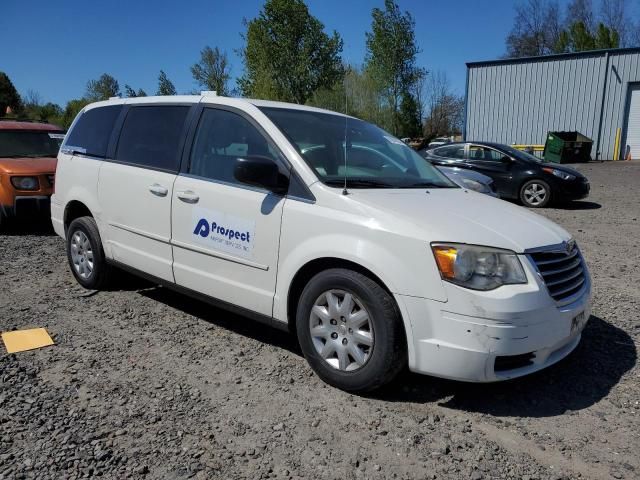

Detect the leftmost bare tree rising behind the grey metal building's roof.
xmin=506 ymin=0 xmax=561 ymax=58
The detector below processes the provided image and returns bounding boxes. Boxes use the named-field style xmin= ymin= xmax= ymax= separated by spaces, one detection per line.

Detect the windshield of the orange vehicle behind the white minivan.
xmin=0 ymin=130 xmax=64 ymax=158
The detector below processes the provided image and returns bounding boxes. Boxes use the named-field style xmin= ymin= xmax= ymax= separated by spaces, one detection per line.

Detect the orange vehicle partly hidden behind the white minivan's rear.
xmin=0 ymin=119 xmax=64 ymax=223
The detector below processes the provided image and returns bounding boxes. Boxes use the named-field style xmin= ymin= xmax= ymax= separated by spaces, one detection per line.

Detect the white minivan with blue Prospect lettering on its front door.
xmin=51 ymin=92 xmax=591 ymax=391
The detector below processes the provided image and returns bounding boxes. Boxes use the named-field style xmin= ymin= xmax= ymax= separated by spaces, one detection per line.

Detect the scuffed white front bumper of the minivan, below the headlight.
xmin=396 ymin=256 xmax=591 ymax=382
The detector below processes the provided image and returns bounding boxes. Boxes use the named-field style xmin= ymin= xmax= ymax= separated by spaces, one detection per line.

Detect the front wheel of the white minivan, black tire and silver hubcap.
xmin=296 ymin=268 xmax=407 ymax=392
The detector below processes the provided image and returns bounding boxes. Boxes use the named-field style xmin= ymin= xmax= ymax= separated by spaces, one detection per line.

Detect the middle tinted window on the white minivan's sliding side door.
xmin=116 ymin=105 xmax=190 ymax=172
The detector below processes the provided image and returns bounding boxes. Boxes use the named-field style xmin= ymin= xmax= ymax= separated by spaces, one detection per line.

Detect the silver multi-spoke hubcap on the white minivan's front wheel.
xmin=309 ymin=290 xmax=374 ymax=372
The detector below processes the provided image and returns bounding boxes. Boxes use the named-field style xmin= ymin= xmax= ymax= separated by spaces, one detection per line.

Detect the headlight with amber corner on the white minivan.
xmin=431 ymin=243 xmax=527 ymax=290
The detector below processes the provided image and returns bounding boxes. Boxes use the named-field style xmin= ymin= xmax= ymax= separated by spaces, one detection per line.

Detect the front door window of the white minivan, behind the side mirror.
xmin=189 ymin=108 xmax=278 ymax=184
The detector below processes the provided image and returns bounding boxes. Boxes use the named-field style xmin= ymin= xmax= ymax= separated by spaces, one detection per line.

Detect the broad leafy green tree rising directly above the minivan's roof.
xmin=238 ymin=0 xmax=344 ymax=104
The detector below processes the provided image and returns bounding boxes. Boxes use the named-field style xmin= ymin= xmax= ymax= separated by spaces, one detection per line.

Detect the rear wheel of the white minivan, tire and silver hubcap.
xmin=66 ymin=217 xmax=112 ymax=290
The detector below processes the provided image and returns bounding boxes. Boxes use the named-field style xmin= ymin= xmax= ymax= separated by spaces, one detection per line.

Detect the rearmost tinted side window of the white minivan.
xmin=65 ymin=105 xmax=122 ymax=158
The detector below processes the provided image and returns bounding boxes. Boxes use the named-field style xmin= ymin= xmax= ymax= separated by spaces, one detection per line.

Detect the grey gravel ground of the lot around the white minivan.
xmin=0 ymin=163 xmax=640 ymax=479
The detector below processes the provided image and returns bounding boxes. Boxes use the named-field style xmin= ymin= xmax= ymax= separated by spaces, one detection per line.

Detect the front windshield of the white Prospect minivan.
xmin=261 ymin=107 xmax=457 ymax=188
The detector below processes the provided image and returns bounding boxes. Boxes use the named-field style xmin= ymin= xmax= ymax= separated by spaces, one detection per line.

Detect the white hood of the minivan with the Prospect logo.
xmin=349 ymin=188 xmax=571 ymax=253
